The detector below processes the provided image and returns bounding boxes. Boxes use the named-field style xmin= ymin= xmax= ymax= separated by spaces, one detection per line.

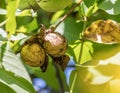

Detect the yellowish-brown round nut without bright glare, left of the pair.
xmin=21 ymin=43 xmax=45 ymax=67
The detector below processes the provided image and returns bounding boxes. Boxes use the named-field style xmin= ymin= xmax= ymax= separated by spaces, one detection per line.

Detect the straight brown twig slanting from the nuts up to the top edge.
xmin=54 ymin=0 xmax=82 ymax=30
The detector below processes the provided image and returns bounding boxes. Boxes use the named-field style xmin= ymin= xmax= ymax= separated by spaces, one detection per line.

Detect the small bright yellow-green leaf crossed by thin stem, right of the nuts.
xmin=67 ymin=41 xmax=93 ymax=64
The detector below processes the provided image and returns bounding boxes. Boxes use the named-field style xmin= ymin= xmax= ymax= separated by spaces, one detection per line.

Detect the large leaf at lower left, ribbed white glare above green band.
xmin=0 ymin=46 xmax=35 ymax=93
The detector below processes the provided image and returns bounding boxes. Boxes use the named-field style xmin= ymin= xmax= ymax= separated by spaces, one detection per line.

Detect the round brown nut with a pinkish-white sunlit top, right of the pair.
xmin=43 ymin=32 xmax=67 ymax=57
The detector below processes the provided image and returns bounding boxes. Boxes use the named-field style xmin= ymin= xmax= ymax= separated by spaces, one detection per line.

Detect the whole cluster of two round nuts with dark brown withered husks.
xmin=21 ymin=25 xmax=70 ymax=72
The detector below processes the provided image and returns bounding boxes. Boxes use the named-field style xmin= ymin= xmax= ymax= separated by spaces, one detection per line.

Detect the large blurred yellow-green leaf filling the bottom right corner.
xmin=70 ymin=58 xmax=120 ymax=93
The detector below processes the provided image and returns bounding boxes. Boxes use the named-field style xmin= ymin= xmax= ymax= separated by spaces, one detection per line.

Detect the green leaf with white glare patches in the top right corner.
xmin=98 ymin=0 xmax=120 ymax=15
